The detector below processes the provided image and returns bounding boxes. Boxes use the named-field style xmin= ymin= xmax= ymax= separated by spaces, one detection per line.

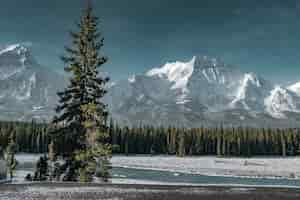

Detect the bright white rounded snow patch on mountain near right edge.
xmin=265 ymin=86 xmax=299 ymax=118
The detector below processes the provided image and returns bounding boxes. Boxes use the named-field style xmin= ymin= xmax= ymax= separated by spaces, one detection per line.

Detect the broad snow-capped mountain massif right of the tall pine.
xmin=107 ymin=56 xmax=300 ymax=126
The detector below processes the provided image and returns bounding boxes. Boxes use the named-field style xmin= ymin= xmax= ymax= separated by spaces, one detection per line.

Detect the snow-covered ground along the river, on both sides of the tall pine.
xmin=9 ymin=154 xmax=300 ymax=184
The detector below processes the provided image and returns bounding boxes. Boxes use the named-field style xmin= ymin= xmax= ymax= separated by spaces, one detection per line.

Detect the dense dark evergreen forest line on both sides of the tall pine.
xmin=0 ymin=121 xmax=300 ymax=156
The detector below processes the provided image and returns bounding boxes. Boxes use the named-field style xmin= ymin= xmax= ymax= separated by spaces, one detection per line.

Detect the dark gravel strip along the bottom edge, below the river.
xmin=0 ymin=183 xmax=300 ymax=200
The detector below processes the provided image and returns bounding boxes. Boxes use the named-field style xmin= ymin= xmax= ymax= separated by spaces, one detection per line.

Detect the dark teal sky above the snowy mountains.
xmin=0 ymin=0 xmax=300 ymax=84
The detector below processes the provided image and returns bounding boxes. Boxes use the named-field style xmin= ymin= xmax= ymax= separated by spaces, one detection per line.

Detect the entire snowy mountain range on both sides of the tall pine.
xmin=0 ymin=44 xmax=300 ymax=127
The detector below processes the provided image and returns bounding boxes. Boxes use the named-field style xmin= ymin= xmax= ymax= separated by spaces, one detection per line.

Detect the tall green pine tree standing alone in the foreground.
xmin=51 ymin=3 xmax=110 ymax=181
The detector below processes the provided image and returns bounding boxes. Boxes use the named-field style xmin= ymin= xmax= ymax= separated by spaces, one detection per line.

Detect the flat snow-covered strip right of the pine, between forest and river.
xmin=112 ymin=156 xmax=300 ymax=179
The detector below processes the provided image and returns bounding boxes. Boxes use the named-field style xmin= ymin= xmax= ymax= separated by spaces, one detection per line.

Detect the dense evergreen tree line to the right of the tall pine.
xmin=109 ymin=123 xmax=300 ymax=157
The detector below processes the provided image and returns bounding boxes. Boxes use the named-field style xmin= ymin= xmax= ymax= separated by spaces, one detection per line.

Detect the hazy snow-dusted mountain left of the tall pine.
xmin=0 ymin=44 xmax=64 ymax=120
